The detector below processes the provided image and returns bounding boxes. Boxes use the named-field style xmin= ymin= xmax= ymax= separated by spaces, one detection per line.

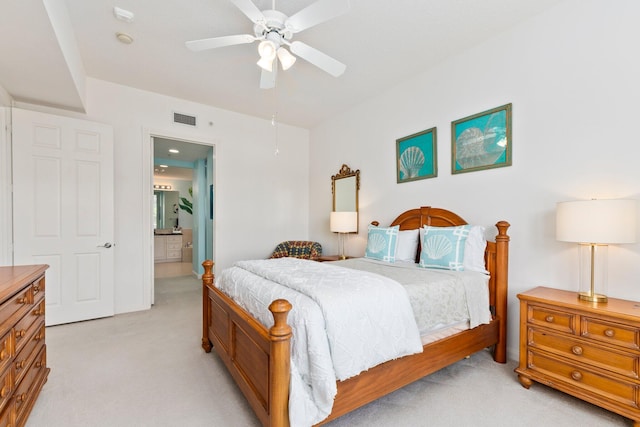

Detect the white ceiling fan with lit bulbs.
xmin=185 ymin=0 xmax=349 ymax=89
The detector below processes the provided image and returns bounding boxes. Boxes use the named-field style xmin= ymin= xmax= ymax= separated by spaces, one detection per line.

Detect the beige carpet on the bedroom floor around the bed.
xmin=27 ymin=277 xmax=632 ymax=427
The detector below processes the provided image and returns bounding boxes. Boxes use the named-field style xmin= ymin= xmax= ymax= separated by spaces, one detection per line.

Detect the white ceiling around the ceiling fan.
xmin=0 ymin=0 xmax=561 ymax=127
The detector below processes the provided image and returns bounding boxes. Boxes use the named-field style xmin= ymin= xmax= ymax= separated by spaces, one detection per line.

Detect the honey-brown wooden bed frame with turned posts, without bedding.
xmin=202 ymin=207 xmax=509 ymax=427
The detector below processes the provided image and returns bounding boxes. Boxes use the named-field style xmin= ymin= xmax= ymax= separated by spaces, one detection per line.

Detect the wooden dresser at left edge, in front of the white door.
xmin=0 ymin=265 xmax=49 ymax=427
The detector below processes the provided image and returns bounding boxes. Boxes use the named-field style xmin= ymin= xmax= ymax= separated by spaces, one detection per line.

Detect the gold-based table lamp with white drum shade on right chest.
xmin=556 ymin=199 xmax=637 ymax=302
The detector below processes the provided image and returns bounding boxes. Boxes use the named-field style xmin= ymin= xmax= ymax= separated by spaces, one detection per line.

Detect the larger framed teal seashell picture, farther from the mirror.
xmin=451 ymin=104 xmax=511 ymax=174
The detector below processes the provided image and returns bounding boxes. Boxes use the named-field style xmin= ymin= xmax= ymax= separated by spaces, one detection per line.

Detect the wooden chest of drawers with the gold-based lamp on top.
xmin=516 ymin=287 xmax=640 ymax=427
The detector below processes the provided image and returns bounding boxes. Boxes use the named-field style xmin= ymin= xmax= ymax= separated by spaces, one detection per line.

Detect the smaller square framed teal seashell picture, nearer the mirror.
xmin=396 ymin=127 xmax=438 ymax=184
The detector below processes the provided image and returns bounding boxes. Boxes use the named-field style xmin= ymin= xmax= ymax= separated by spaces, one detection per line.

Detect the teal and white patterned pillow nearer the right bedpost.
xmin=419 ymin=225 xmax=471 ymax=271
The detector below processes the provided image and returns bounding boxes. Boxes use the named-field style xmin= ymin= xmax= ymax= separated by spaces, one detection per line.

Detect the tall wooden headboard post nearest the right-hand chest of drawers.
xmin=493 ymin=221 xmax=511 ymax=363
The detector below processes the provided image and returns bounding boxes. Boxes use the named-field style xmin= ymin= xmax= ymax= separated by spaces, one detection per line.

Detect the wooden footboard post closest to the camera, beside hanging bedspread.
xmin=269 ymin=299 xmax=292 ymax=427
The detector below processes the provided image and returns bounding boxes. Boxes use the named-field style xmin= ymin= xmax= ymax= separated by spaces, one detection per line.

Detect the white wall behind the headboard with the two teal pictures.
xmin=310 ymin=0 xmax=640 ymax=358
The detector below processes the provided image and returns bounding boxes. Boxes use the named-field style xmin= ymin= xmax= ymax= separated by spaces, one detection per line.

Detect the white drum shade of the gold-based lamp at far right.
xmin=556 ymin=199 xmax=637 ymax=244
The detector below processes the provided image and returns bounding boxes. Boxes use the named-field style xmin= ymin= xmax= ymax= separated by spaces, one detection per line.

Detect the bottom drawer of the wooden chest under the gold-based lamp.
xmin=529 ymin=351 xmax=640 ymax=409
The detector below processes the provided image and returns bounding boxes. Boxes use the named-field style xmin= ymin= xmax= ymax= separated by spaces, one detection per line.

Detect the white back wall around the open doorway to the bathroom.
xmin=15 ymin=79 xmax=309 ymax=313
